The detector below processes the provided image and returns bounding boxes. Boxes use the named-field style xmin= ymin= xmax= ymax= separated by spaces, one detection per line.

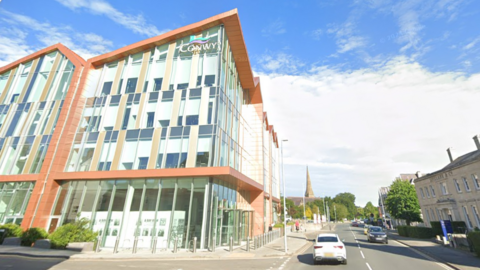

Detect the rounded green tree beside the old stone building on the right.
xmin=385 ymin=179 xmax=422 ymax=226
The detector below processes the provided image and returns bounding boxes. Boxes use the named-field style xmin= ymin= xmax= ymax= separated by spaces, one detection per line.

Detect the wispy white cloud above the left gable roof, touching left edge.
xmin=0 ymin=10 xmax=113 ymax=63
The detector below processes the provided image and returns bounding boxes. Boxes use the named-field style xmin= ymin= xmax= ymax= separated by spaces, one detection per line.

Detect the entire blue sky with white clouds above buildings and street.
xmin=0 ymin=0 xmax=480 ymax=206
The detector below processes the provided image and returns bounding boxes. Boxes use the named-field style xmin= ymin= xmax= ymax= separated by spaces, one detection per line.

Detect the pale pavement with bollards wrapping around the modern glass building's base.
xmin=0 ymin=224 xmax=334 ymax=260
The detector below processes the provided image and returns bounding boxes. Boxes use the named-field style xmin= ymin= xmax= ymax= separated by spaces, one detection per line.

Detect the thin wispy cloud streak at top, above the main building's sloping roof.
xmin=56 ymin=0 xmax=169 ymax=37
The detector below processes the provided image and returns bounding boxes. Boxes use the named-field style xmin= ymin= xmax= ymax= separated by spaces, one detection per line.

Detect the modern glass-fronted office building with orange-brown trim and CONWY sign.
xmin=0 ymin=10 xmax=280 ymax=249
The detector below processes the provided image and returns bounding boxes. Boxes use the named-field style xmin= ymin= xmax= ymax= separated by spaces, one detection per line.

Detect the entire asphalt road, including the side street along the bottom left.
xmin=0 ymin=224 xmax=450 ymax=270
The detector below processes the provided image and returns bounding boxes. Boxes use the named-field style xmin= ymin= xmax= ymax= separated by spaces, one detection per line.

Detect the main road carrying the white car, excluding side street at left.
xmin=282 ymin=224 xmax=450 ymax=270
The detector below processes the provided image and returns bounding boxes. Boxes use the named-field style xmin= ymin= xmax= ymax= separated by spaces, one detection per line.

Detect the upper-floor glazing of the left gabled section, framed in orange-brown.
xmin=0 ymin=51 xmax=74 ymax=175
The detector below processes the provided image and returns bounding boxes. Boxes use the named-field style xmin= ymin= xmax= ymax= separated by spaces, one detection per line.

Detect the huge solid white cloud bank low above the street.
xmin=260 ymin=57 xmax=480 ymax=205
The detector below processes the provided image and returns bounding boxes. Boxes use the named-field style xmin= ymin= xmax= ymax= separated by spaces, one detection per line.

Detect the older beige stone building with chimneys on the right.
xmin=414 ymin=135 xmax=480 ymax=230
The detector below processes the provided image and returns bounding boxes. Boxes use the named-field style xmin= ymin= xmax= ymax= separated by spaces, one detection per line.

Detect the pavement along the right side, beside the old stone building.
xmin=388 ymin=230 xmax=480 ymax=270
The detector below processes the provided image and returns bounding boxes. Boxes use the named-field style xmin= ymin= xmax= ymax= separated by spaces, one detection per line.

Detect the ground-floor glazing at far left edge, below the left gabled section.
xmin=0 ymin=182 xmax=35 ymax=225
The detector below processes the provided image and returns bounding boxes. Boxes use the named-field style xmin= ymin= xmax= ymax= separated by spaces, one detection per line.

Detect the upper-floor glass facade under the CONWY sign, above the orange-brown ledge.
xmin=65 ymin=26 xmax=263 ymax=183
